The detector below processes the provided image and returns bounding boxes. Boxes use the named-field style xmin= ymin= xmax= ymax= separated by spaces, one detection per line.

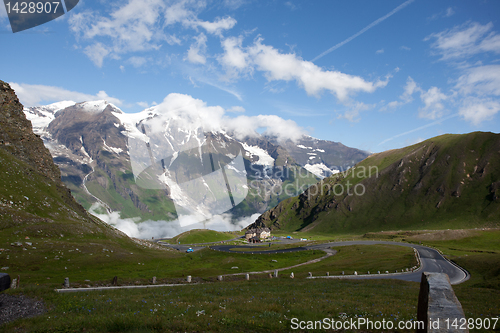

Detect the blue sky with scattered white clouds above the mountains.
xmin=0 ymin=0 xmax=500 ymax=152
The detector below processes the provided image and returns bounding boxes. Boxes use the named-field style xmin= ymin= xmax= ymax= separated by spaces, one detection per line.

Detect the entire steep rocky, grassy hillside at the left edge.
xmin=0 ymin=81 xmax=123 ymax=240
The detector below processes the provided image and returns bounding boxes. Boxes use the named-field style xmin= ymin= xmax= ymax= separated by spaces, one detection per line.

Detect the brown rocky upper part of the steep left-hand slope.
xmin=0 ymin=81 xmax=61 ymax=183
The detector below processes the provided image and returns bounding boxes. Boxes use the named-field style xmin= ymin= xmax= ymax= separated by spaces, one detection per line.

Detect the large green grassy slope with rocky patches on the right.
xmin=249 ymin=132 xmax=500 ymax=233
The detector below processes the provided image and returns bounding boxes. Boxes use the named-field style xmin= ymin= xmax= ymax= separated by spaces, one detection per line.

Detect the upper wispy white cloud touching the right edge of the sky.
xmin=424 ymin=22 xmax=500 ymax=60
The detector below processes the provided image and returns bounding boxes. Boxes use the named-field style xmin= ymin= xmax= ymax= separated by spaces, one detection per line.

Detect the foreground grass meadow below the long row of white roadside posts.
xmin=3 ymin=278 xmax=424 ymax=333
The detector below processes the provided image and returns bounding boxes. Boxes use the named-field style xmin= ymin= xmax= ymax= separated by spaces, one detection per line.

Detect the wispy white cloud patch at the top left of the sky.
xmin=68 ymin=0 xmax=237 ymax=67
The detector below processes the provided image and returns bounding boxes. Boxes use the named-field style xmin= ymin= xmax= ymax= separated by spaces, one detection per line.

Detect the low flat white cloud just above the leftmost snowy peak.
xmin=10 ymin=82 xmax=123 ymax=107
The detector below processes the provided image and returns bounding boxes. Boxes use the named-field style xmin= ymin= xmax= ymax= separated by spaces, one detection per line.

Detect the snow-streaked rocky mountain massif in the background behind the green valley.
xmin=24 ymin=101 xmax=367 ymax=226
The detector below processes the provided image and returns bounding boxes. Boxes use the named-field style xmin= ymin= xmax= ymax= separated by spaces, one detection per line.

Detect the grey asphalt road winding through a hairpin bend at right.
xmin=210 ymin=241 xmax=470 ymax=284
